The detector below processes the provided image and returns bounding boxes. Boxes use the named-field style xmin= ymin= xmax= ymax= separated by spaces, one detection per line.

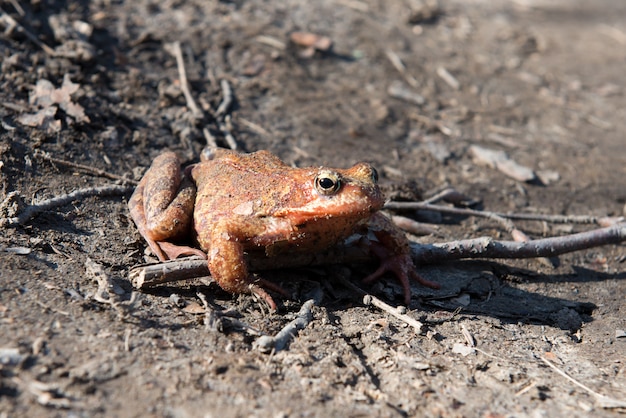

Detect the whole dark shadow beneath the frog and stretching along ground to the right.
xmin=136 ymin=260 xmax=626 ymax=332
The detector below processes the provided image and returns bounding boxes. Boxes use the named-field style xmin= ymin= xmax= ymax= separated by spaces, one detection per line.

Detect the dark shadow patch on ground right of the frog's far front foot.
xmin=346 ymin=260 xmax=626 ymax=332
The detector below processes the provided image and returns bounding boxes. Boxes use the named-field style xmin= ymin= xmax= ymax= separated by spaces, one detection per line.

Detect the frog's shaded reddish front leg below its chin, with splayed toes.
xmin=363 ymin=213 xmax=441 ymax=306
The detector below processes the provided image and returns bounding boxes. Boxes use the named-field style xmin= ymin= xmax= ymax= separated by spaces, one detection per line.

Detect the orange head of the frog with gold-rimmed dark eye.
xmin=276 ymin=163 xmax=385 ymax=224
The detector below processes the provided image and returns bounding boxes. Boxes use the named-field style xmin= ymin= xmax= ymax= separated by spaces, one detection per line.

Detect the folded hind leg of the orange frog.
xmin=128 ymin=152 xmax=206 ymax=261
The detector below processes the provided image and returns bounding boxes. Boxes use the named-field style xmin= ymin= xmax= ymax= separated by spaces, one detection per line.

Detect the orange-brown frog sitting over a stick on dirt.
xmin=128 ymin=148 xmax=439 ymax=311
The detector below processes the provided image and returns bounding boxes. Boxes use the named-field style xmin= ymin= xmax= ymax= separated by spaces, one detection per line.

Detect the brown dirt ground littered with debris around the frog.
xmin=0 ymin=0 xmax=626 ymax=417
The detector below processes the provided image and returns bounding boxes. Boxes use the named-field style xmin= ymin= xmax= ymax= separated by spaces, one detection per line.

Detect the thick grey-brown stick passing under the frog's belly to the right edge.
xmin=129 ymin=223 xmax=626 ymax=289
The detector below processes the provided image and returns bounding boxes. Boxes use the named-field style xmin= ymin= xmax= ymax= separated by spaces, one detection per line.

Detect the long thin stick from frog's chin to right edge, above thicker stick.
xmin=385 ymin=202 xmax=624 ymax=225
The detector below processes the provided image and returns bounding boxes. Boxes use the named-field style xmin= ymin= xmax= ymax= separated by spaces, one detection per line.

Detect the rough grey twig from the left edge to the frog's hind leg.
xmin=0 ymin=184 xmax=134 ymax=227
